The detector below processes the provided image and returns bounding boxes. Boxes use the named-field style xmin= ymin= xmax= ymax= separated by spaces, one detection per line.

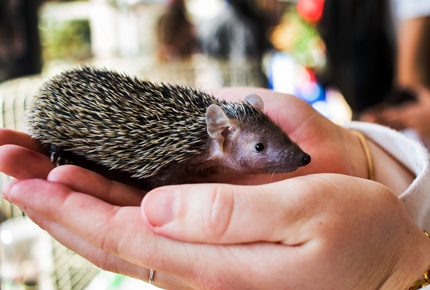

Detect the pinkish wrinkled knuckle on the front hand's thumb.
xmin=203 ymin=186 xmax=235 ymax=242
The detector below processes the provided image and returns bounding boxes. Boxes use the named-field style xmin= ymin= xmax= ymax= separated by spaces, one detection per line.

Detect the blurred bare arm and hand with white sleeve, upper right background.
xmin=361 ymin=0 xmax=430 ymax=148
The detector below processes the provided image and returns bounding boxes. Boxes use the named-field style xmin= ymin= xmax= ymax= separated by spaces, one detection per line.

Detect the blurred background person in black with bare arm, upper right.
xmin=319 ymin=0 xmax=430 ymax=148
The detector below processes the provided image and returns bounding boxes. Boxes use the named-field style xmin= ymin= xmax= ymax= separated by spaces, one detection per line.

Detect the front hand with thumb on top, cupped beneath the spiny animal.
xmin=3 ymin=165 xmax=430 ymax=290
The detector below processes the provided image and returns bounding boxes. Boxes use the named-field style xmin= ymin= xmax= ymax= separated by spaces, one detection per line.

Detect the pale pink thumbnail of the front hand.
xmin=142 ymin=188 xmax=178 ymax=227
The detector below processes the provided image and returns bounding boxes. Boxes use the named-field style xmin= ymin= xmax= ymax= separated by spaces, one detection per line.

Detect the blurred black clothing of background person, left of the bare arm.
xmin=318 ymin=0 xmax=395 ymax=115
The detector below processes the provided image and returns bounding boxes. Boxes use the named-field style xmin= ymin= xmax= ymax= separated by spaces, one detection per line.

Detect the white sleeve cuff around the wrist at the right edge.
xmin=343 ymin=122 xmax=430 ymax=232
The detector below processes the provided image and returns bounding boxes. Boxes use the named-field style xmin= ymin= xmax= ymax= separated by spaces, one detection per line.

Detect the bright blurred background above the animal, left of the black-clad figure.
xmin=0 ymin=0 xmax=351 ymax=121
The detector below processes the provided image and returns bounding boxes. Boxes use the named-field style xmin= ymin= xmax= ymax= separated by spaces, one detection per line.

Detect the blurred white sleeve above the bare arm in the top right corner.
xmin=393 ymin=0 xmax=430 ymax=19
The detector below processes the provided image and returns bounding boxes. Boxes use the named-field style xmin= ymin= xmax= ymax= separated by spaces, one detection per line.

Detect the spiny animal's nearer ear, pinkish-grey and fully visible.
xmin=205 ymin=104 xmax=231 ymax=145
